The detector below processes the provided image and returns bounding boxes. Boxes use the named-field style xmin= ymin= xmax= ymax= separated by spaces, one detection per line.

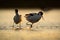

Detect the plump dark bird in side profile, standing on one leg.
xmin=24 ymin=11 xmax=43 ymax=29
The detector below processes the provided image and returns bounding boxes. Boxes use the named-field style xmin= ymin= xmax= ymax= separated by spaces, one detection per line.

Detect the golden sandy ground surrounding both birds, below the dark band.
xmin=0 ymin=9 xmax=60 ymax=40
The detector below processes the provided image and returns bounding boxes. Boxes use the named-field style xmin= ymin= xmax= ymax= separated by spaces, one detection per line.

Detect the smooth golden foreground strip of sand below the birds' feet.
xmin=0 ymin=29 xmax=60 ymax=40
